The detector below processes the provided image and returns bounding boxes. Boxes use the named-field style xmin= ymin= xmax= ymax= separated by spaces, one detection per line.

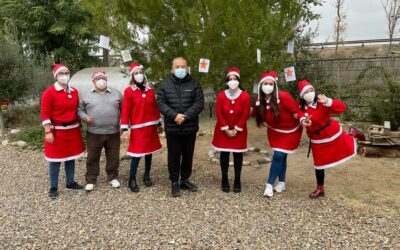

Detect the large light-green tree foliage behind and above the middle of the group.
xmin=84 ymin=0 xmax=320 ymax=88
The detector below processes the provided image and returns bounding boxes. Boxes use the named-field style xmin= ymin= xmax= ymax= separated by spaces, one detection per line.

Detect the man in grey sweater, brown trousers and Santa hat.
xmin=78 ymin=71 xmax=122 ymax=192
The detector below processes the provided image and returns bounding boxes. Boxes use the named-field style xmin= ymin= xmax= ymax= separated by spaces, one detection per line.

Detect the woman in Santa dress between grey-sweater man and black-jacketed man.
xmin=121 ymin=63 xmax=162 ymax=192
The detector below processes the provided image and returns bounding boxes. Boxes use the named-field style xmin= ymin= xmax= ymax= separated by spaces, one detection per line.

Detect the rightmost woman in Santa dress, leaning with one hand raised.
xmin=297 ymin=80 xmax=357 ymax=198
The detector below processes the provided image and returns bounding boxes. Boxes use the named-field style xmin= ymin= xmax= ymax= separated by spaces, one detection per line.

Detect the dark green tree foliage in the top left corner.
xmin=0 ymin=0 xmax=97 ymax=70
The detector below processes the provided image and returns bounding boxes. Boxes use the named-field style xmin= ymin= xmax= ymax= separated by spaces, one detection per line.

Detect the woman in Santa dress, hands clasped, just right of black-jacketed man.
xmin=212 ymin=67 xmax=251 ymax=193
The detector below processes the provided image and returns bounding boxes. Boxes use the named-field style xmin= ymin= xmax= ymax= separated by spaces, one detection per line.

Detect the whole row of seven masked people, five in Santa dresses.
xmin=41 ymin=57 xmax=356 ymax=198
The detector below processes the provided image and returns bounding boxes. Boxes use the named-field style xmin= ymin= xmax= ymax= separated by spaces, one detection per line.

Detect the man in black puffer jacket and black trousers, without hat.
xmin=157 ymin=57 xmax=204 ymax=197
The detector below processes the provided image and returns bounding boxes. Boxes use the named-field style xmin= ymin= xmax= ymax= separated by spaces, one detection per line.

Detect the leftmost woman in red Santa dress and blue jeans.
xmin=41 ymin=64 xmax=85 ymax=199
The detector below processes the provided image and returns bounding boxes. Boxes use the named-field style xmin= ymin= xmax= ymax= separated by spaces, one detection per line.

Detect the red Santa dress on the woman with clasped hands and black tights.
xmin=212 ymin=89 xmax=251 ymax=152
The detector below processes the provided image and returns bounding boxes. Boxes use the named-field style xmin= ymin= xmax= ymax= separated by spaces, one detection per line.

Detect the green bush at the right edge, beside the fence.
xmin=369 ymin=79 xmax=400 ymax=130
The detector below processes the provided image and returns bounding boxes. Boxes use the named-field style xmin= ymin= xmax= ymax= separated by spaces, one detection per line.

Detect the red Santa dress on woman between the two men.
xmin=121 ymin=84 xmax=162 ymax=157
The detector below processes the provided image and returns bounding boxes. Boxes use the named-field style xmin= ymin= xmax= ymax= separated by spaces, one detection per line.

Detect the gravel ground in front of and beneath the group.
xmin=0 ymin=146 xmax=400 ymax=249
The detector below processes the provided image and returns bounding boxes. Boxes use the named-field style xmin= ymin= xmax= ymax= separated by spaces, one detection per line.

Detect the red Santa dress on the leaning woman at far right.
xmin=301 ymin=99 xmax=357 ymax=169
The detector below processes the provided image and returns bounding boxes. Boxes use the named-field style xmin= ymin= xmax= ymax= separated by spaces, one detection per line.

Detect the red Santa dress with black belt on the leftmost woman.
xmin=41 ymin=83 xmax=85 ymax=162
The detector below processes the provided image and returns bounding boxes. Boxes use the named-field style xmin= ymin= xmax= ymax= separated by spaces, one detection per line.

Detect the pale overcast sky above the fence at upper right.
xmin=311 ymin=0 xmax=392 ymax=42
